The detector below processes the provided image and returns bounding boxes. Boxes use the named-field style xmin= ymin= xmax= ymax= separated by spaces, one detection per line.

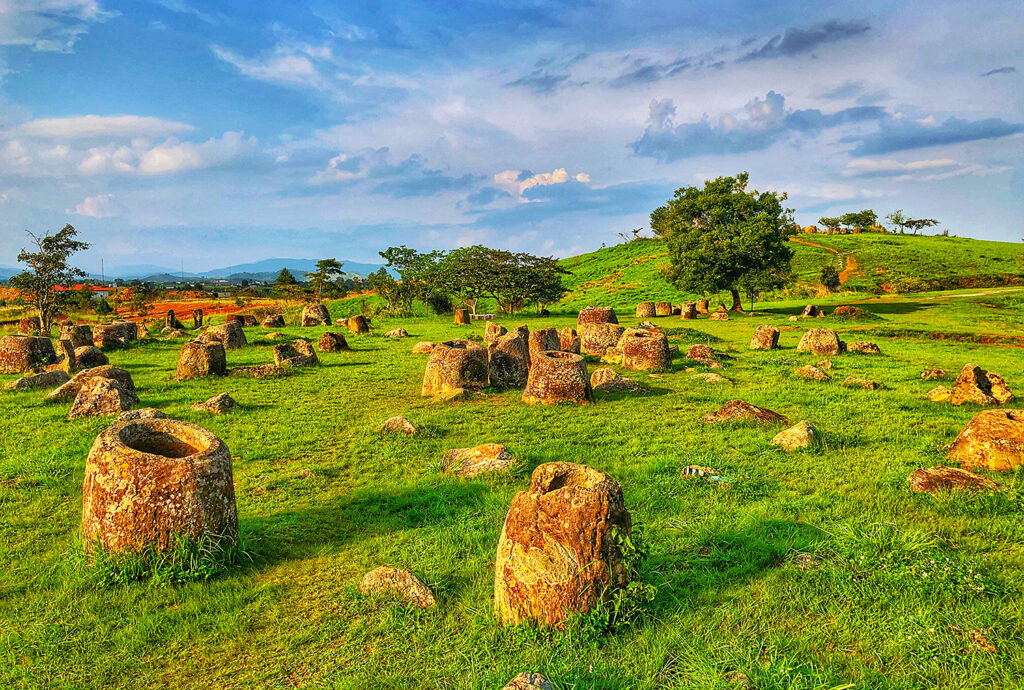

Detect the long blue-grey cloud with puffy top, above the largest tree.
xmin=632 ymin=91 xmax=886 ymax=163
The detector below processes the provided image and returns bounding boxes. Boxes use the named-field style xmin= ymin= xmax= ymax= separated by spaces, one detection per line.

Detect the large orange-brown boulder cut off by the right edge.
xmin=946 ymin=409 xmax=1024 ymax=470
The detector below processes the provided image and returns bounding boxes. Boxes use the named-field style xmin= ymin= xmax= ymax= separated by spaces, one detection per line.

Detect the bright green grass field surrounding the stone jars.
xmin=0 ymin=288 xmax=1024 ymax=690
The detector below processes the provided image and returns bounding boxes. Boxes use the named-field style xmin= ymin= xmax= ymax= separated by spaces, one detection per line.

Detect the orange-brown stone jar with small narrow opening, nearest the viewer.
xmin=495 ymin=463 xmax=633 ymax=628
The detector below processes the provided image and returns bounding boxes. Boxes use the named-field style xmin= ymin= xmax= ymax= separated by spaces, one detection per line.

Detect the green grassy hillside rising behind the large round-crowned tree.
xmin=560 ymin=234 xmax=1024 ymax=308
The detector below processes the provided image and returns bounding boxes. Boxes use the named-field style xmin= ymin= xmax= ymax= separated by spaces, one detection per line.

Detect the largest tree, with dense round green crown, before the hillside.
xmin=650 ymin=172 xmax=793 ymax=310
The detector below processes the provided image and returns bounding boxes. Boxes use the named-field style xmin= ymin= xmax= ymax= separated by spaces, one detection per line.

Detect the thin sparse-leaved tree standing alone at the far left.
xmin=10 ymin=225 xmax=89 ymax=334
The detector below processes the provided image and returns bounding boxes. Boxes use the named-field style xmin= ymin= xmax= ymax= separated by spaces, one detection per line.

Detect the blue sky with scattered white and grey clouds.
xmin=0 ymin=0 xmax=1024 ymax=270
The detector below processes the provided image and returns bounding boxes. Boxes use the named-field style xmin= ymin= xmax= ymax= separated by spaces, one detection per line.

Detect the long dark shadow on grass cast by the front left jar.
xmin=242 ymin=483 xmax=487 ymax=568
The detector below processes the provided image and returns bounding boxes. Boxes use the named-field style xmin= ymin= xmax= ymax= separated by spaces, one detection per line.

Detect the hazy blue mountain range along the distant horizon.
xmin=0 ymin=259 xmax=381 ymax=283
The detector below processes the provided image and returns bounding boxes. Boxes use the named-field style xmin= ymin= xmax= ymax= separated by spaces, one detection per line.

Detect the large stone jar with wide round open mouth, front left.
xmin=82 ymin=419 xmax=239 ymax=552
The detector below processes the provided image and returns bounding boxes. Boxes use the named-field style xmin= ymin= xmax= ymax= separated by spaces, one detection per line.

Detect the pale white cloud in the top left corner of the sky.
xmin=0 ymin=0 xmax=117 ymax=52
